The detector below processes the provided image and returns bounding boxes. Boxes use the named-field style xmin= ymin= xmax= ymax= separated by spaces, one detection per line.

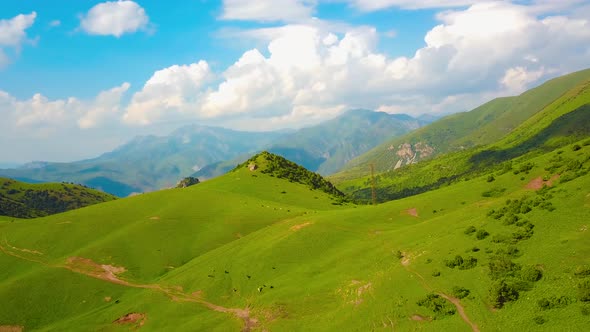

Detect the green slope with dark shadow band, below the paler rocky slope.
xmin=331 ymin=71 xmax=590 ymax=201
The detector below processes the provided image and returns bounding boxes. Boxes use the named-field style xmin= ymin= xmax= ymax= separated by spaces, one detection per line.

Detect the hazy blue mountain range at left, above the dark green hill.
xmin=0 ymin=125 xmax=283 ymax=197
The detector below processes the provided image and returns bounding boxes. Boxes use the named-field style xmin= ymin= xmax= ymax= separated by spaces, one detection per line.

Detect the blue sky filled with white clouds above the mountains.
xmin=0 ymin=0 xmax=590 ymax=163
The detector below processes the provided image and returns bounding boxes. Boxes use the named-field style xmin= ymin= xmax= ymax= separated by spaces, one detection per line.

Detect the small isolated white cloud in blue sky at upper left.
xmin=80 ymin=0 xmax=149 ymax=37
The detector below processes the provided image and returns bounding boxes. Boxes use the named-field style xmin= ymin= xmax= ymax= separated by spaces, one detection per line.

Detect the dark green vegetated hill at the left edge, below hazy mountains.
xmin=0 ymin=178 xmax=115 ymax=218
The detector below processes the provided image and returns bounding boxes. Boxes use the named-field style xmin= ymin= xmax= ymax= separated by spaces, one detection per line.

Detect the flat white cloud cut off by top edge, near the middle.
xmin=221 ymin=0 xmax=317 ymax=22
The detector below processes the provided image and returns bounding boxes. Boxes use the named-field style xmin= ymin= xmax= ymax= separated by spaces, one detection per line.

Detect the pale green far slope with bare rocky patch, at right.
xmin=334 ymin=69 xmax=590 ymax=181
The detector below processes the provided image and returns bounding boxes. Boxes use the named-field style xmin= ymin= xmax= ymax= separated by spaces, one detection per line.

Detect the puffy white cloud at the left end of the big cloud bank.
xmin=124 ymin=61 xmax=213 ymax=125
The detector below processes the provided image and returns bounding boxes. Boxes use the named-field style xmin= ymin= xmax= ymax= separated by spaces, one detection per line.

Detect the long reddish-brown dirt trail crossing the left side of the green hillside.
xmin=0 ymin=240 xmax=258 ymax=332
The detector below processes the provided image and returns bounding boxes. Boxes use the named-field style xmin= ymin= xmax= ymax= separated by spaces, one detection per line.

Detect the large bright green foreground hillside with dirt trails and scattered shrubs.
xmin=0 ymin=142 xmax=590 ymax=331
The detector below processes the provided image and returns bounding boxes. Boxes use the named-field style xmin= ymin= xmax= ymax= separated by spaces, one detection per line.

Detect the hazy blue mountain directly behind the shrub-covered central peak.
xmin=193 ymin=110 xmax=432 ymax=179
